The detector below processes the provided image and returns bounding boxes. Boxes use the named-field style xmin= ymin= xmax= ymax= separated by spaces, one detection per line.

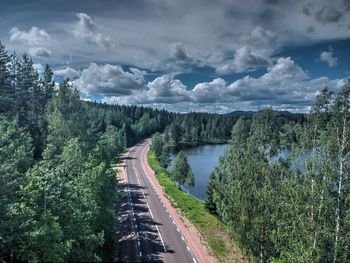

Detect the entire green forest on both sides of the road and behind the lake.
xmin=0 ymin=37 xmax=350 ymax=262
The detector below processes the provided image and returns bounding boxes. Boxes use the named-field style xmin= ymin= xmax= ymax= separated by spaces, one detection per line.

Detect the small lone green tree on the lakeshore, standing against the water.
xmin=171 ymin=151 xmax=194 ymax=187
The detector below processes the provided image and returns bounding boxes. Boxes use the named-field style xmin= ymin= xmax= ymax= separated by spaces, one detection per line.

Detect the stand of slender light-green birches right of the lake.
xmin=207 ymin=82 xmax=350 ymax=262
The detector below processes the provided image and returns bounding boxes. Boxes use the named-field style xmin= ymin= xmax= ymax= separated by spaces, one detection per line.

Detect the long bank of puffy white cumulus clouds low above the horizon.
xmin=99 ymin=57 xmax=344 ymax=113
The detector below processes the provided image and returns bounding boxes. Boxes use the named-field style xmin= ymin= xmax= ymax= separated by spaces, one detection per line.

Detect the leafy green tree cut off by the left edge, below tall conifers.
xmin=0 ymin=116 xmax=33 ymax=261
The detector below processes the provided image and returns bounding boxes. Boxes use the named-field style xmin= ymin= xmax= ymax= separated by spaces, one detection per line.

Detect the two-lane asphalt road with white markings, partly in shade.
xmin=117 ymin=143 xmax=197 ymax=263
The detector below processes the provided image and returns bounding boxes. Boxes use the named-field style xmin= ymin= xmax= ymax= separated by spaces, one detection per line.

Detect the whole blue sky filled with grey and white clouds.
xmin=0 ymin=0 xmax=350 ymax=113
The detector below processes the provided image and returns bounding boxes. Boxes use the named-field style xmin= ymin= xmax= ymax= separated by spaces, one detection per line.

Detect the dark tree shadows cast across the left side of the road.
xmin=115 ymin=184 xmax=175 ymax=262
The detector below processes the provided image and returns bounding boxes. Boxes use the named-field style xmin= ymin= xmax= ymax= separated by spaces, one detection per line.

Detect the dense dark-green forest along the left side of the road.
xmin=0 ymin=44 xmax=174 ymax=262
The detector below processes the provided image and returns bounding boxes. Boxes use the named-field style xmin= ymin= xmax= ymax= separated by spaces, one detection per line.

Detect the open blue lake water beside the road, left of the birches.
xmin=168 ymin=144 xmax=228 ymax=201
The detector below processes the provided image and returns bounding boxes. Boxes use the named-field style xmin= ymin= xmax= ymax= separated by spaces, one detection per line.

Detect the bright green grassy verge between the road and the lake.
xmin=147 ymin=150 xmax=248 ymax=262
